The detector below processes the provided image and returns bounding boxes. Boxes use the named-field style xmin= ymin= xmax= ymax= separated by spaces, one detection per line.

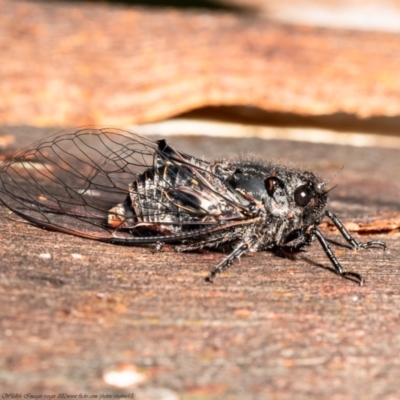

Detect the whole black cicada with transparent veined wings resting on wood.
xmin=0 ymin=129 xmax=385 ymax=284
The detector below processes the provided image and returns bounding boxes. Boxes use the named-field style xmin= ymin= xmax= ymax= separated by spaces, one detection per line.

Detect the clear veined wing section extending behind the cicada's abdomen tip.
xmin=0 ymin=130 xmax=157 ymax=238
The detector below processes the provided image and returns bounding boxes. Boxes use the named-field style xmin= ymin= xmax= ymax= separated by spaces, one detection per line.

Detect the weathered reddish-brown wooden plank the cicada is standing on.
xmin=0 ymin=129 xmax=400 ymax=400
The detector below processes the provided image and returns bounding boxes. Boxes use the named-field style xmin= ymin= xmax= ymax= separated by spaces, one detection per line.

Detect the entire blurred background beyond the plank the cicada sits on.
xmin=0 ymin=0 xmax=400 ymax=147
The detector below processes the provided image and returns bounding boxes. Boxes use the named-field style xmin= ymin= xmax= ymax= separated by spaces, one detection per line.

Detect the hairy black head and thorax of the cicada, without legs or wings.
xmin=222 ymin=160 xmax=327 ymax=249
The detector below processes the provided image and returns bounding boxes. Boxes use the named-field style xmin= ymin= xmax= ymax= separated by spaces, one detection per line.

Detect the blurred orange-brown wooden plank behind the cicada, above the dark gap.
xmin=0 ymin=0 xmax=400 ymax=126
